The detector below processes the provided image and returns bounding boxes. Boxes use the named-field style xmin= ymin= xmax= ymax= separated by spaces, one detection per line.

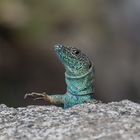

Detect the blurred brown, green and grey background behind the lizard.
xmin=0 ymin=0 xmax=140 ymax=107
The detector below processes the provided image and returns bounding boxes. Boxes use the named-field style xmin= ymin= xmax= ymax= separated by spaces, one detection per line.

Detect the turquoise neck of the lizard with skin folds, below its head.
xmin=65 ymin=66 xmax=95 ymax=95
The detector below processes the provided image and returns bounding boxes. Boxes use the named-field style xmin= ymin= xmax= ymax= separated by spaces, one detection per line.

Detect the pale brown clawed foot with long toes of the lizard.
xmin=24 ymin=92 xmax=50 ymax=102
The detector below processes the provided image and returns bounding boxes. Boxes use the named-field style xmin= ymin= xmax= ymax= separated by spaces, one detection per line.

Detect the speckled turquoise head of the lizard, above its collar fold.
xmin=55 ymin=45 xmax=92 ymax=76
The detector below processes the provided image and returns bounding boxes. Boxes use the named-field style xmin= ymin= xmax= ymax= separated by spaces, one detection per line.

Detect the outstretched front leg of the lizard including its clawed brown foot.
xmin=24 ymin=92 xmax=64 ymax=105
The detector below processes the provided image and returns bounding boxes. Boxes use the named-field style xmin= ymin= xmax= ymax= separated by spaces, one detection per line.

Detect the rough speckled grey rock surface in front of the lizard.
xmin=0 ymin=100 xmax=140 ymax=140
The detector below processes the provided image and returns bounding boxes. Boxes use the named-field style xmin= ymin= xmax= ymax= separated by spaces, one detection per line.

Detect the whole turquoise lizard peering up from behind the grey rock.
xmin=24 ymin=44 xmax=95 ymax=109
